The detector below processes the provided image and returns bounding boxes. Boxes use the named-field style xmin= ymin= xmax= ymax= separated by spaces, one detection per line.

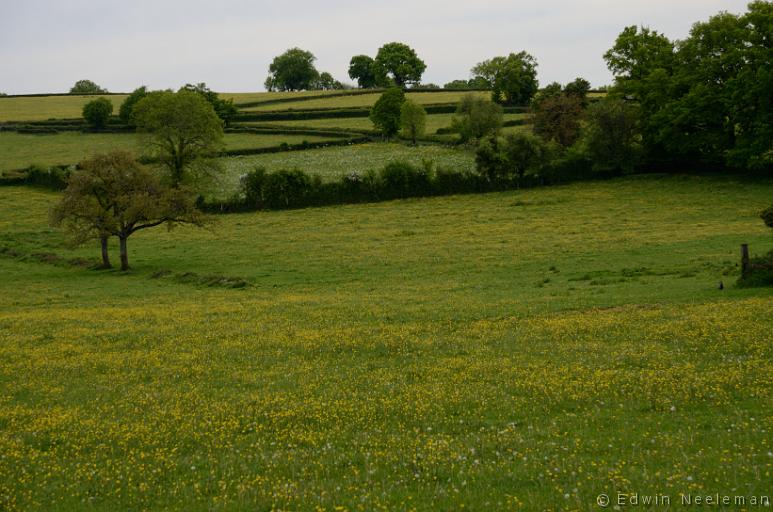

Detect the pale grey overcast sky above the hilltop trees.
xmin=0 ymin=0 xmax=747 ymax=94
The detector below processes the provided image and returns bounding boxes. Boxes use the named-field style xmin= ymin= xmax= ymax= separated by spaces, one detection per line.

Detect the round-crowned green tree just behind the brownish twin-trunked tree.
xmin=134 ymin=89 xmax=223 ymax=187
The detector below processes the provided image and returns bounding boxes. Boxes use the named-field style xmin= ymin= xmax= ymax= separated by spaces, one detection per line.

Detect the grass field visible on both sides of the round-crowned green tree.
xmin=0 ymin=132 xmax=340 ymax=171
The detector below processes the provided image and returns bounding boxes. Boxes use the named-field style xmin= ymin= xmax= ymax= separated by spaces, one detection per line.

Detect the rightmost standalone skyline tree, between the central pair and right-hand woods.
xmin=472 ymin=52 xmax=538 ymax=105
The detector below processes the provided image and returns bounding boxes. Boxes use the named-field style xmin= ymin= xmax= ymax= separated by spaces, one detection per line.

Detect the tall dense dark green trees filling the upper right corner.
xmin=605 ymin=1 xmax=773 ymax=171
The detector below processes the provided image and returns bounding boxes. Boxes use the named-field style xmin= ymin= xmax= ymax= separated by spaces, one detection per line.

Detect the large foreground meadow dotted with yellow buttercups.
xmin=0 ymin=176 xmax=773 ymax=511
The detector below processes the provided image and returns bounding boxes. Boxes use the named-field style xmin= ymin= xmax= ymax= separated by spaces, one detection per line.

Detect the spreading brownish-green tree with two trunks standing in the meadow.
xmin=51 ymin=151 xmax=203 ymax=270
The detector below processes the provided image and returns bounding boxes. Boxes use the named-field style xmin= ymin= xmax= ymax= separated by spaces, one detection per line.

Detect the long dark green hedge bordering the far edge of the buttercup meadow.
xmin=198 ymin=155 xmax=608 ymax=213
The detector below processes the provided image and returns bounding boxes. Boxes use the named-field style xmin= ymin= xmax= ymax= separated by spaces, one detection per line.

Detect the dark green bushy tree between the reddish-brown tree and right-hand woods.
xmin=582 ymin=98 xmax=641 ymax=173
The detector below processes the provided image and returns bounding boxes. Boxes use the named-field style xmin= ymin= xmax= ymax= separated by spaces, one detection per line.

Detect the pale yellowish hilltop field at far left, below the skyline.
xmin=0 ymin=95 xmax=126 ymax=123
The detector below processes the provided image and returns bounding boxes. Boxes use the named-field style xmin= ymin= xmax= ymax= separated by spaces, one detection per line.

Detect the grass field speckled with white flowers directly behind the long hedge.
xmin=220 ymin=143 xmax=475 ymax=195
